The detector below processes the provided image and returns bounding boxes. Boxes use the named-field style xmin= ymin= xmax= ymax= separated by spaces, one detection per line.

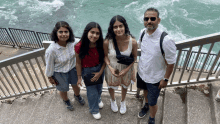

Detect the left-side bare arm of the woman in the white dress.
xmin=103 ymin=40 xmax=119 ymax=77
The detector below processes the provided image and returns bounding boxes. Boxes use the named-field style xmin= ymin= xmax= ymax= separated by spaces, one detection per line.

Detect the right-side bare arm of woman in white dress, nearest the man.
xmin=119 ymin=38 xmax=137 ymax=76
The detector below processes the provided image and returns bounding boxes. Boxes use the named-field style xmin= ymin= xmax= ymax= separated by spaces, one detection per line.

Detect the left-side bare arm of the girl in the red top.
xmin=75 ymin=52 xmax=82 ymax=86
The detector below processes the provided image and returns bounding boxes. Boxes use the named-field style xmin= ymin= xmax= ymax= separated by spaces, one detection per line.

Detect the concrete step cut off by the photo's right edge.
xmin=211 ymin=81 xmax=220 ymax=124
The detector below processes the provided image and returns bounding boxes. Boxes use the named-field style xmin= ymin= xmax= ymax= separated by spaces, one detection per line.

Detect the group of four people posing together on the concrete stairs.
xmin=45 ymin=8 xmax=176 ymax=124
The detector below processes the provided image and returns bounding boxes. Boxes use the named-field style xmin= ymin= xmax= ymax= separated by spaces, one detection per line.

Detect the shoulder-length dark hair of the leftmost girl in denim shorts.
xmin=51 ymin=21 xmax=75 ymax=43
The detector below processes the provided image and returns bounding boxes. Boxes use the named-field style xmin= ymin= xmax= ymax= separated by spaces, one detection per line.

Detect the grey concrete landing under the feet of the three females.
xmin=0 ymin=90 xmax=144 ymax=124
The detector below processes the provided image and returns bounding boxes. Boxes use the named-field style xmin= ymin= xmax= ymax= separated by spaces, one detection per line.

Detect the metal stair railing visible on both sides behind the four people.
xmin=0 ymin=28 xmax=220 ymax=100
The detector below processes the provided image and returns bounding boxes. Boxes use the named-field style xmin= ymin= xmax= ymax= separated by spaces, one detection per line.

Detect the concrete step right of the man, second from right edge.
xmin=187 ymin=85 xmax=212 ymax=124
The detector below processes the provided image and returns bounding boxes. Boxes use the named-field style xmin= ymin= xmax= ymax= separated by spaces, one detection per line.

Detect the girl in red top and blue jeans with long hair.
xmin=75 ymin=22 xmax=105 ymax=119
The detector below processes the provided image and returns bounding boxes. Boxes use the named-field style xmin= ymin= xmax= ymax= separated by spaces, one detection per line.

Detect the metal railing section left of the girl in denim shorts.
xmin=0 ymin=48 xmax=54 ymax=100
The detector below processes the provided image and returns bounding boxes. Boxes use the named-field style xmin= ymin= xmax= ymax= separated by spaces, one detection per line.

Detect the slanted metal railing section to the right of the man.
xmin=169 ymin=33 xmax=220 ymax=86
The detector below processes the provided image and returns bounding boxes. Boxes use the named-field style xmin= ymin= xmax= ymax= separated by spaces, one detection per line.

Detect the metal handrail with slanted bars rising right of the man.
xmin=169 ymin=33 xmax=220 ymax=86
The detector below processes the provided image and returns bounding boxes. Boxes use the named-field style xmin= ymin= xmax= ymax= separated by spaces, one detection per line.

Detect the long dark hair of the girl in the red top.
xmin=79 ymin=22 xmax=104 ymax=63
